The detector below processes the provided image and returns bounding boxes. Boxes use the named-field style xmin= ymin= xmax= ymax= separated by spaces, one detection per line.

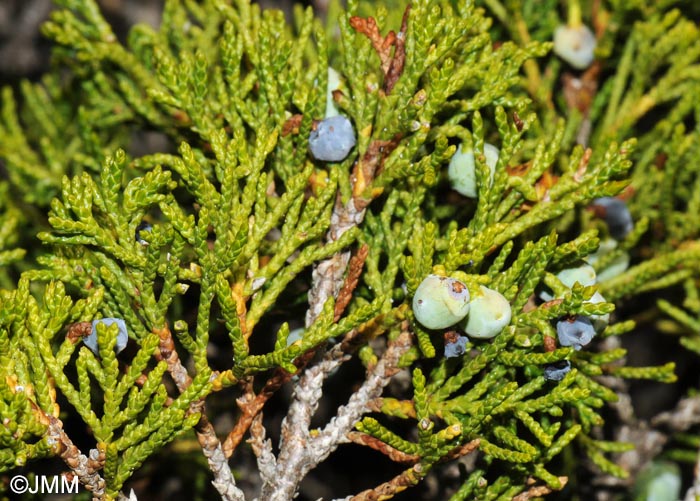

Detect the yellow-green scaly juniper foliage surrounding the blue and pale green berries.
xmin=0 ymin=0 xmax=700 ymax=500
